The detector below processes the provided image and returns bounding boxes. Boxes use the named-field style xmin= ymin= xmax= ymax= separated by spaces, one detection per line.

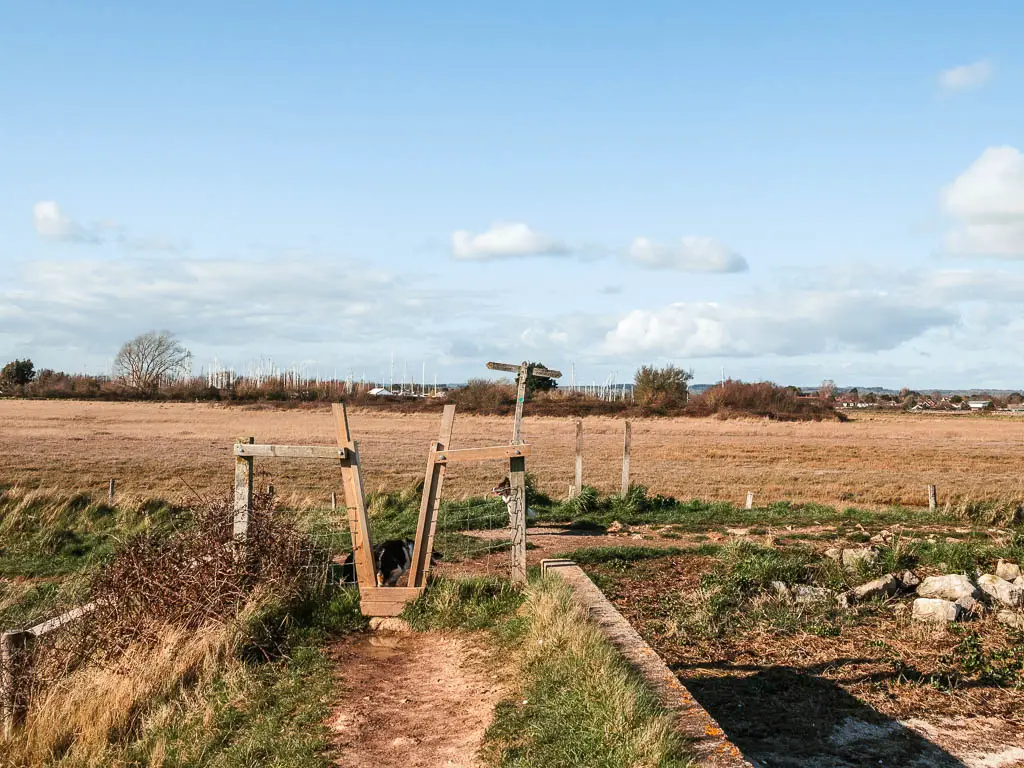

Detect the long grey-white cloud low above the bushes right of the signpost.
xmin=604 ymin=291 xmax=958 ymax=357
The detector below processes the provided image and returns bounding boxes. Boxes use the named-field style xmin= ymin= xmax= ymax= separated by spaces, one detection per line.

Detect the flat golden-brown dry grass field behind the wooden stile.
xmin=0 ymin=400 xmax=1024 ymax=507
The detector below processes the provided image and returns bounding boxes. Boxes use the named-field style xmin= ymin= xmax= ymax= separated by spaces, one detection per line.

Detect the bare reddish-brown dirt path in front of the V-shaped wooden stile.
xmin=329 ymin=633 xmax=504 ymax=768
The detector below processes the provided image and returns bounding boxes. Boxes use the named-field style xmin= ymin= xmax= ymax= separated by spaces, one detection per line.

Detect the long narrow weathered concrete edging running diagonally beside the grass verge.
xmin=541 ymin=560 xmax=752 ymax=768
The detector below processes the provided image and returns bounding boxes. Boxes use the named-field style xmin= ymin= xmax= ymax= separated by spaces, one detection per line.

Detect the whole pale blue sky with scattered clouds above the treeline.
xmin=0 ymin=0 xmax=1024 ymax=388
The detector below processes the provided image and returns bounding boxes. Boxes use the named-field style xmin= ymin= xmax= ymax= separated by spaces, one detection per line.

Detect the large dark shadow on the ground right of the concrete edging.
xmin=673 ymin=665 xmax=966 ymax=768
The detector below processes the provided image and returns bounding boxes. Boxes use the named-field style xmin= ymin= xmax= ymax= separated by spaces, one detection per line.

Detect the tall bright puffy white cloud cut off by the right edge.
xmin=943 ymin=146 xmax=1024 ymax=258
